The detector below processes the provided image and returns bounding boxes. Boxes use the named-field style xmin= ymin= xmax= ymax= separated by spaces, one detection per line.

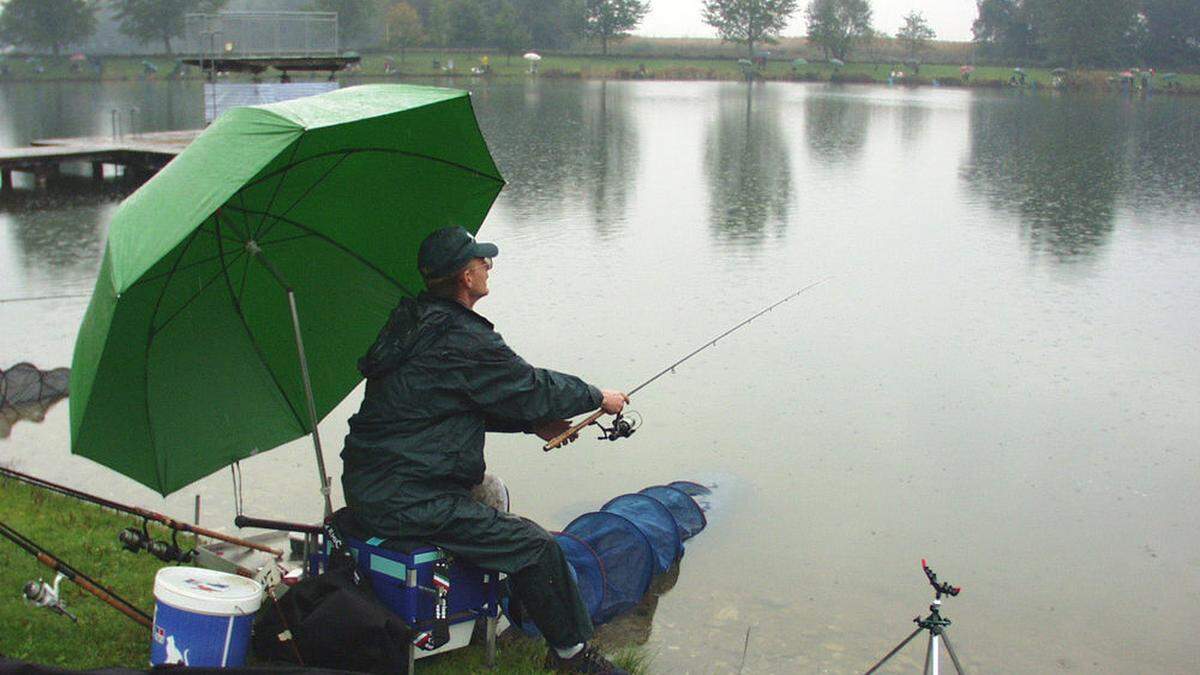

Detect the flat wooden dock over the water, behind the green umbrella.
xmin=0 ymin=130 xmax=200 ymax=191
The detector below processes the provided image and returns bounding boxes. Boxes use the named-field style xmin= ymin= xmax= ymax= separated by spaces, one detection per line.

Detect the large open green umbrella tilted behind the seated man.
xmin=71 ymin=85 xmax=504 ymax=509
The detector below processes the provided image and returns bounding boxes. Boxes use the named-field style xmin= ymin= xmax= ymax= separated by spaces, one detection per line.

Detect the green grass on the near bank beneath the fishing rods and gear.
xmin=0 ymin=478 xmax=649 ymax=675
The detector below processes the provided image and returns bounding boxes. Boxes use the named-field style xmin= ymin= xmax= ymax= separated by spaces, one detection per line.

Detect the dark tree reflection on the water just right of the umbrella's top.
xmin=473 ymin=79 xmax=638 ymax=235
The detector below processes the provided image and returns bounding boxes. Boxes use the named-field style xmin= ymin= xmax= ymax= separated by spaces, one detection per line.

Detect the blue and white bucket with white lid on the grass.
xmin=150 ymin=567 xmax=263 ymax=668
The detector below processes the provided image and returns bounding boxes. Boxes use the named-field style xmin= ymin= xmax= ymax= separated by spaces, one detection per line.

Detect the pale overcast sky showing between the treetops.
xmin=635 ymin=0 xmax=977 ymax=40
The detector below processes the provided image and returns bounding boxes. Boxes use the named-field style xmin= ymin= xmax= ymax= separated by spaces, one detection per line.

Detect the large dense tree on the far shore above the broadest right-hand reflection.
xmin=1025 ymin=0 xmax=1138 ymax=67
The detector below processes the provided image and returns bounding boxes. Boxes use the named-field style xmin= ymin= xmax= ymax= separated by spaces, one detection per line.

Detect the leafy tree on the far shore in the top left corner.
xmin=0 ymin=0 xmax=96 ymax=56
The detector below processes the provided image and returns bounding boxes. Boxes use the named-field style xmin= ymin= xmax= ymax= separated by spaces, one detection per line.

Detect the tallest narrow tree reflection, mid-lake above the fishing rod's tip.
xmin=704 ymin=84 xmax=792 ymax=244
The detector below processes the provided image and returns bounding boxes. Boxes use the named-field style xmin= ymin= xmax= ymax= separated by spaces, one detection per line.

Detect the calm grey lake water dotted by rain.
xmin=0 ymin=80 xmax=1200 ymax=673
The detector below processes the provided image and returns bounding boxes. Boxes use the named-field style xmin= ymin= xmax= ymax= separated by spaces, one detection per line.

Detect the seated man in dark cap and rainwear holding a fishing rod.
xmin=342 ymin=227 xmax=629 ymax=674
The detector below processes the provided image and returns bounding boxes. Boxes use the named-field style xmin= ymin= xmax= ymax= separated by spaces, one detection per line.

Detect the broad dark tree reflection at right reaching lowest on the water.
xmin=962 ymin=96 xmax=1128 ymax=261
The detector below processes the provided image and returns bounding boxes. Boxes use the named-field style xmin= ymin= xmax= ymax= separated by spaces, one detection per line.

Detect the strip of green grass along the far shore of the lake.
xmin=0 ymin=50 xmax=1200 ymax=95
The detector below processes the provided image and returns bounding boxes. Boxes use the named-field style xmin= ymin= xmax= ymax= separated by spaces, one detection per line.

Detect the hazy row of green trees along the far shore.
xmin=0 ymin=0 xmax=1200 ymax=67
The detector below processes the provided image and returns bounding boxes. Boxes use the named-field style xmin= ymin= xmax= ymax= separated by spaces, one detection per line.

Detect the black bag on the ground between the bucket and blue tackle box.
xmin=252 ymin=565 xmax=413 ymax=673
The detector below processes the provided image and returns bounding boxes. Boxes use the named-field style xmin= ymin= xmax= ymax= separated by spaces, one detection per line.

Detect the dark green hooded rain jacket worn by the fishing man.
xmin=342 ymin=294 xmax=601 ymax=536
